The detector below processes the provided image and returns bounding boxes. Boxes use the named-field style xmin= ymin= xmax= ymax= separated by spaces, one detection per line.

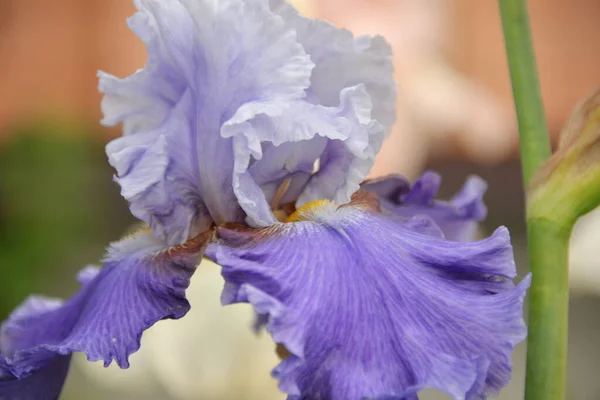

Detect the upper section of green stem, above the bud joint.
xmin=499 ymin=0 xmax=550 ymax=187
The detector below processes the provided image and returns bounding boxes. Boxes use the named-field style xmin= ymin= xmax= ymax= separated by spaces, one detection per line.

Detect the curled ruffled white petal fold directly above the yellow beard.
xmin=230 ymin=85 xmax=385 ymax=226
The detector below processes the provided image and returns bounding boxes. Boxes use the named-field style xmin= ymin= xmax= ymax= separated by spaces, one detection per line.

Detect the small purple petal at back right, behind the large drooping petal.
xmin=361 ymin=172 xmax=487 ymax=242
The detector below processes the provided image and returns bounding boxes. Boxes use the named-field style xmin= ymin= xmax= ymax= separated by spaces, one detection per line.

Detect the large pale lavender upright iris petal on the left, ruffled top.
xmin=100 ymin=0 xmax=314 ymax=239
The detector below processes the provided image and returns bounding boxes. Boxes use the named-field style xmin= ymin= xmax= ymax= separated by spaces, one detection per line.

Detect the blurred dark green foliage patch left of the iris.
xmin=0 ymin=121 xmax=132 ymax=319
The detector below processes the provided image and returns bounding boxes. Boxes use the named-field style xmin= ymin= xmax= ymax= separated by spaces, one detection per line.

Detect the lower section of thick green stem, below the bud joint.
xmin=525 ymin=219 xmax=571 ymax=400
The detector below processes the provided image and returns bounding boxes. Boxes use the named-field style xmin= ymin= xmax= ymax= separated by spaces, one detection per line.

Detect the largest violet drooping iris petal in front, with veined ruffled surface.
xmin=207 ymin=203 xmax=530 ymax=400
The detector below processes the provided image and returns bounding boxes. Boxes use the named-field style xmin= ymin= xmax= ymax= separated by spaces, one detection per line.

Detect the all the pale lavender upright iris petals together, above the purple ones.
xmin=100 ymin=0 xmax=395 ymax=238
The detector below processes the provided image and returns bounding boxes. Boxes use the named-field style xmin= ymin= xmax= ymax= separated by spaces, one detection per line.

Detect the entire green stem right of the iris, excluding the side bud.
xmin=499 ymin=0 xmax=572 ymax=400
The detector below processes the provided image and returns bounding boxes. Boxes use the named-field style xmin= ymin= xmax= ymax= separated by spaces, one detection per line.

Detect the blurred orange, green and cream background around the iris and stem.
xmin=0 ymin=0 xmax=600 ymax=400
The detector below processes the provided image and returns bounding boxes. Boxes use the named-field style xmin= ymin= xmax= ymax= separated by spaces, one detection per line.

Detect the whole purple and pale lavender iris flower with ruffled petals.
xmin=0 ymin=0 xmax=529 ymax=400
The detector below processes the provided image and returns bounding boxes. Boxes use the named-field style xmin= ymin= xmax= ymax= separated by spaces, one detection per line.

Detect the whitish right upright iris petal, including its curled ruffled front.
xmin=231 ymin=0 xmax=395 ymax=226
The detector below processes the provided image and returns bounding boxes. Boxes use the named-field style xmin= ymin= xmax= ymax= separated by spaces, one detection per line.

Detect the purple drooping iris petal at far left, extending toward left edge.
xmin=0 ymin=230 xmax=210 ymax=398
